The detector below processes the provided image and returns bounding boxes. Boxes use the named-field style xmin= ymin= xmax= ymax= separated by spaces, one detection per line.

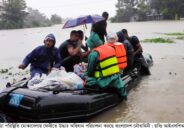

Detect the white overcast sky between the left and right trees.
xmin=25 ymin=0 xmax=117 ymax=18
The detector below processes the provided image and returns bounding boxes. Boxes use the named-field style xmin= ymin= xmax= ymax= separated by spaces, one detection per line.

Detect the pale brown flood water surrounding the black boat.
xmin=0 ymin=21 xmax=184 ymax=122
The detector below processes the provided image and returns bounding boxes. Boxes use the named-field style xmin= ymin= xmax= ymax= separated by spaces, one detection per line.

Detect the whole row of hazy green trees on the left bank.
xmin=0 ymin=0 xmax=62 ymax=29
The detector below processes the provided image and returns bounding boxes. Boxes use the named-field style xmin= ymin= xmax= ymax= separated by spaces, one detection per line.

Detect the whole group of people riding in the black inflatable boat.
xmin=19 ymin=12 xmax=142 ymax=97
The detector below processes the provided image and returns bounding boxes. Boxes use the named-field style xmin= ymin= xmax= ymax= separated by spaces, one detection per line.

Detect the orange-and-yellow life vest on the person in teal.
xmin=93 ymin=44 xmax=120 ymax=78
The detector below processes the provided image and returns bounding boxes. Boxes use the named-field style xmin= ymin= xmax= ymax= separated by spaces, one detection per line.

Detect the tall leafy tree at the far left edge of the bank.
xmin=1 ymin=0 xmax=27 ymax=29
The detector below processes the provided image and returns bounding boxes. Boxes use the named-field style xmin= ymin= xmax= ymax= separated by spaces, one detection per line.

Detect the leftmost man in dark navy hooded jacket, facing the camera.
xmin=19 ymin=34 xmax=62 ymax=78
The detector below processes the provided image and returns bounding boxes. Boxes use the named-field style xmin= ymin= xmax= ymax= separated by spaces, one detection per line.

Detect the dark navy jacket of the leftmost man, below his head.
xmin=23 ymin=46 xmax=62 ymax=77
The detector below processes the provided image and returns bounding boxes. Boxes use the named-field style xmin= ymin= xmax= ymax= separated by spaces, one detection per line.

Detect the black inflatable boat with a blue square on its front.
xmin=0 ymin=53 xmax=153 ymax=122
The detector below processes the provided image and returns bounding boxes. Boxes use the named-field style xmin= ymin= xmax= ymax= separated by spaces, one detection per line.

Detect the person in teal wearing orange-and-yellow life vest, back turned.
xmin=86 ymin=32 xmax=127 ymax=97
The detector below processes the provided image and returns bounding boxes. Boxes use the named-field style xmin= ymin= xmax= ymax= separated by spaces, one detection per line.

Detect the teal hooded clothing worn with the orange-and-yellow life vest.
xmin=85 ymin=33 xmax=127 ymax=96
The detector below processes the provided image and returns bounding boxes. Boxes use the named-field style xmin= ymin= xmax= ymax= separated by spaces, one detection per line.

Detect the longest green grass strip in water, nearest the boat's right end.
xmin=141 ymin=38 xmax=175 ymax=43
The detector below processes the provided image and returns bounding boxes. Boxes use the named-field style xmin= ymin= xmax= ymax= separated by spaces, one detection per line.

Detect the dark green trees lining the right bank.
xmin=111 ymin=0 xmax=184 ymax=22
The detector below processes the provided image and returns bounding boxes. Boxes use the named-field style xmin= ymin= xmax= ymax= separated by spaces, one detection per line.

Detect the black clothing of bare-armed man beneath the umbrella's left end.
xmin=59 ymin=39 xmax=81 ymax=72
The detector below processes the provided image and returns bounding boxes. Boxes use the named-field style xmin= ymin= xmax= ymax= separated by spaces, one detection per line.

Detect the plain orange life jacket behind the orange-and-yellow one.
xmin=107 ymin=42 xmax=127 ymax=69
